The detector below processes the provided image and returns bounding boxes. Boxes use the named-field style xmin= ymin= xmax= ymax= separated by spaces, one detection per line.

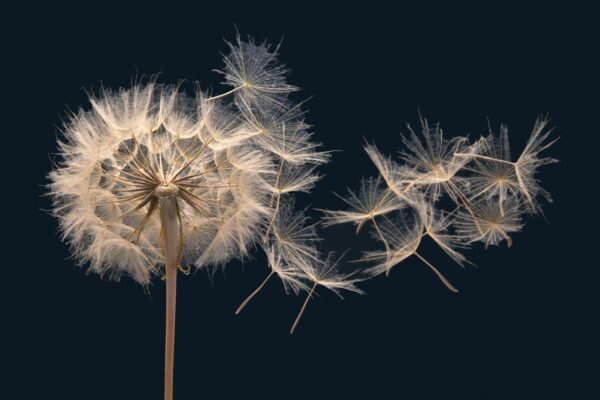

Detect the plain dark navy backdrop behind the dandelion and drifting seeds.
xmin=1 ymin=2 xmax=600 ymax=400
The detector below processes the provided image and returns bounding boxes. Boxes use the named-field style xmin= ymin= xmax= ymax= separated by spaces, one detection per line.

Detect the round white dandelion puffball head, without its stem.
xmin=51 ymin=83 xmax=264 ymax=284
